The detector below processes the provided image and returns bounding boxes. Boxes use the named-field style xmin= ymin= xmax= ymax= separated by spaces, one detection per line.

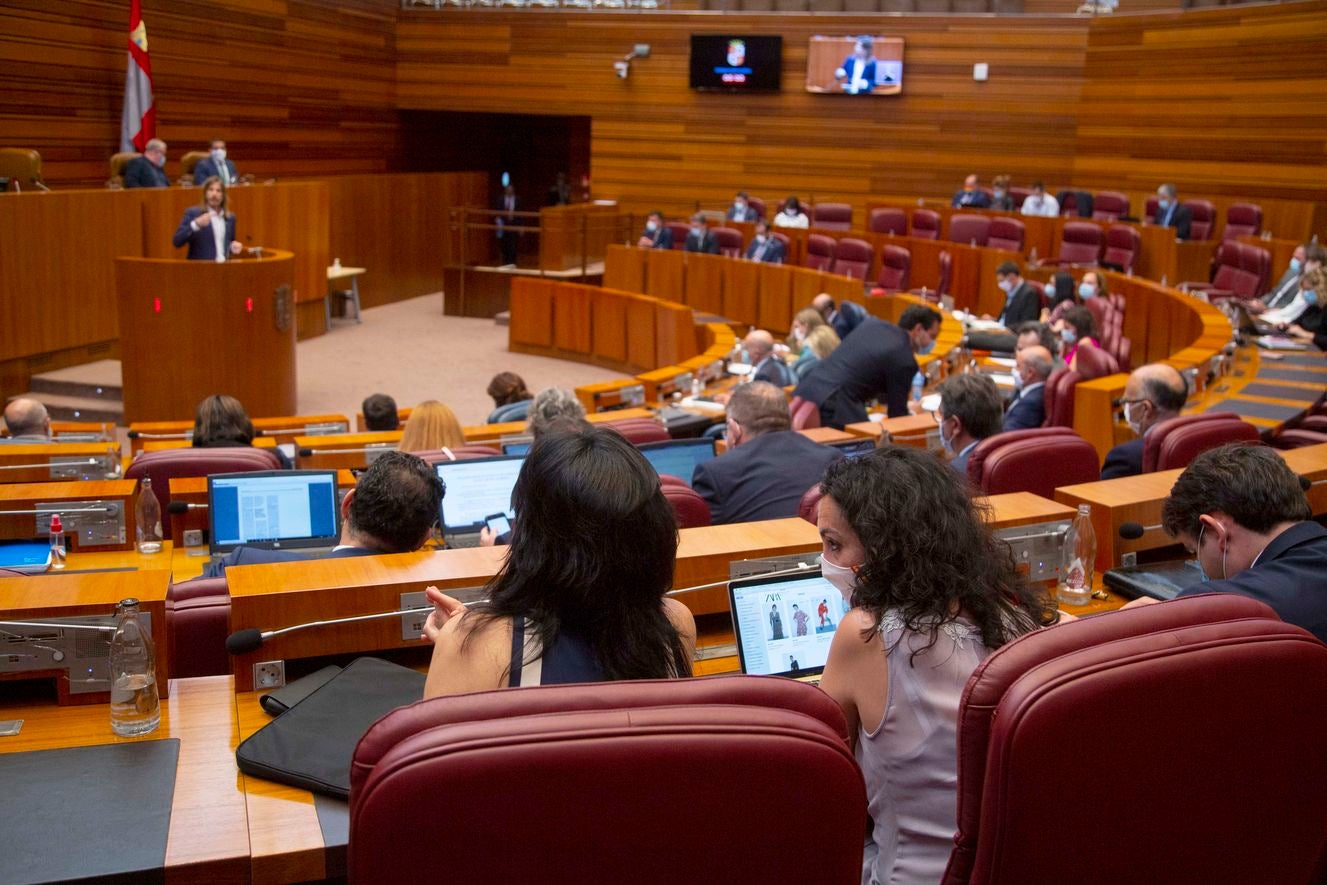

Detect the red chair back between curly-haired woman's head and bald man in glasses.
xmin=967 ymin=427 xmax=1101 ymax=500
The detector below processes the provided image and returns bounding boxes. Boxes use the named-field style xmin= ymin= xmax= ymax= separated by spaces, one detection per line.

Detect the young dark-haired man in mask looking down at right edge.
xmin=1135 ymin=444 xmax=1327 ymax=642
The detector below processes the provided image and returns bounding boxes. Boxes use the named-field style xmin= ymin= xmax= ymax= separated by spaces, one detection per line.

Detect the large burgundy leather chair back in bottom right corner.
xmin=941 ymin=593 xmax=1327 ymax=885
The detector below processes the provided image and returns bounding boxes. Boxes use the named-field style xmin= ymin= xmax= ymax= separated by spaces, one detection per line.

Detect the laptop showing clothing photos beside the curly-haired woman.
xmin=729 ymin=569 xmax=848 ymax=683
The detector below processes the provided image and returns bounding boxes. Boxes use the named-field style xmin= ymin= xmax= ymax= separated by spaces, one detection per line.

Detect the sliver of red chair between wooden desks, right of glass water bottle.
xmin=165 ymin=578 xmax=231 ymax=679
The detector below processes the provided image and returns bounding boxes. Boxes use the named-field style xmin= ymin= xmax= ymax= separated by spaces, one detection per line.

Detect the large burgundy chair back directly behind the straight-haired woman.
xmin=346 ymin=677 xmax=867 ymax=882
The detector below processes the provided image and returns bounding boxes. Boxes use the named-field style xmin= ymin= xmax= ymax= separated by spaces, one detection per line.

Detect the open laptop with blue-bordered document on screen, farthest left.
xmin=207 ymin=470 xmax=341 ymax=560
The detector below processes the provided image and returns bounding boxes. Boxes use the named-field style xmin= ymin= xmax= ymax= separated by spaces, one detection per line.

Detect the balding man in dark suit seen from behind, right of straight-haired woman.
xmin=691 ymin=381 xmax=843 ymax=524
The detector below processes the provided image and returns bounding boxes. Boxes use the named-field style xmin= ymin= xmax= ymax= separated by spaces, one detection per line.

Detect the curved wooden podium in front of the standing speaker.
xmin=115 ymin=249 xmax=296 ymax=422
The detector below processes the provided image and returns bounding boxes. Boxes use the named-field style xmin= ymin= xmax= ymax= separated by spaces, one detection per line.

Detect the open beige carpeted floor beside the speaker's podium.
xmin=296 ymin=295 xmax=624 ymax=425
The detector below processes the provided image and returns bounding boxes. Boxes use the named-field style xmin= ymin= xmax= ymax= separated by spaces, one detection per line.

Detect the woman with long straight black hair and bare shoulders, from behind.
xmin=425 ymin=430 xmax=695 ymax=697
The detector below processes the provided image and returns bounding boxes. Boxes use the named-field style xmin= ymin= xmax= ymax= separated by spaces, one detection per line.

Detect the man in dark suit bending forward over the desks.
xmin=794 ymin=304 xmax=940 ymax=429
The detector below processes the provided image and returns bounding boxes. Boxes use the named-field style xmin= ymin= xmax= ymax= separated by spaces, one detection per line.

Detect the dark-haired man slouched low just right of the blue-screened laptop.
xmin=203 ymin=451 xmax=446 ymax=577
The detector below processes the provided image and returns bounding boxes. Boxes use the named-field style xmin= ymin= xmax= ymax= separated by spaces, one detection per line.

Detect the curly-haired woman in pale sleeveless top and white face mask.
xmin=819 ymin=446 xmax=1054 ymax=884
